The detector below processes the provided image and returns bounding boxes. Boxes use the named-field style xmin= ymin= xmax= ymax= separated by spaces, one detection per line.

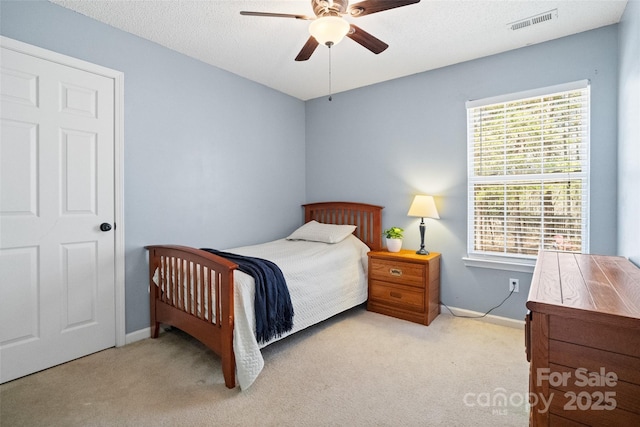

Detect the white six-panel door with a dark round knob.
xmin=0 ymin=40 xmax=116 ymax=382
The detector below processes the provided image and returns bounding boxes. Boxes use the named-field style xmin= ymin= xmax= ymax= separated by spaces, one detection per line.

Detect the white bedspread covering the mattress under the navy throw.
xmin=225 ymin=236 xmax=369 ymax=389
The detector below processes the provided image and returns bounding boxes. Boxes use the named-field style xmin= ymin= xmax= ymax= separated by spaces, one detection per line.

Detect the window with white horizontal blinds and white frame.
xmin=467 ymin=81 xmax=589 ymax=261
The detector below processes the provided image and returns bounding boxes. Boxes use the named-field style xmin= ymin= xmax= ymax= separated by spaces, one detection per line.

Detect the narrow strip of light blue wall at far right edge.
xmin=618 ymin=0 xmax=640 ymax=267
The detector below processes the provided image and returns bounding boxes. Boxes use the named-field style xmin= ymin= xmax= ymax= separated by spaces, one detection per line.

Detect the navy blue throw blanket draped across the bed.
xmin=202 ymin=248 xmax=293 ymax=343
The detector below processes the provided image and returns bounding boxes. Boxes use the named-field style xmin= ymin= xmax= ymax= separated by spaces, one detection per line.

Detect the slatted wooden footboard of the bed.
xmin=146 ymin=245 xmax=238 ymax=388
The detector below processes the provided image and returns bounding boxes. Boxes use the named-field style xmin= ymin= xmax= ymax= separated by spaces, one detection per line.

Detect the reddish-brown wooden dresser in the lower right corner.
xmin=525 ymin=251 xmax=640 ymax=427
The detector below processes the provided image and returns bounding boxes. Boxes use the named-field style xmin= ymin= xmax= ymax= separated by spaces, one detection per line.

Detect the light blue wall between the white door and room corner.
xmin=0 ymin=0 xmax=305 ymax=332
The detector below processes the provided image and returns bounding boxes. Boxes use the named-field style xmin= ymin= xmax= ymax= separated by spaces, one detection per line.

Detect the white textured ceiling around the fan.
xmin=50 ymin=0 xmax=627 ymax=100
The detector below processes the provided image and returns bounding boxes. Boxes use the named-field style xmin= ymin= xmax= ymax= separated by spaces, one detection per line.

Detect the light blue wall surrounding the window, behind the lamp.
xmin=306 ymin=25 xmax=618 ymax=319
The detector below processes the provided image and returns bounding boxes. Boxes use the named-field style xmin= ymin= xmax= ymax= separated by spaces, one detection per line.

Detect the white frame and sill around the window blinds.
xmin=463 ymin=80 xmax=591 ymax=272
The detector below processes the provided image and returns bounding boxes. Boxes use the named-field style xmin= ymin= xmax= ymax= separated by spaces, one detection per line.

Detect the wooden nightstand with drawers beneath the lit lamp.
xmin=367 ymin=249 xmax=440 ymax=325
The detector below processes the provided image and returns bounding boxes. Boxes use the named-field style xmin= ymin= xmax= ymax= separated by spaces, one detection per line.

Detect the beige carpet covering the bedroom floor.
xmin=0 ymin=307 xmax=528 ymax=427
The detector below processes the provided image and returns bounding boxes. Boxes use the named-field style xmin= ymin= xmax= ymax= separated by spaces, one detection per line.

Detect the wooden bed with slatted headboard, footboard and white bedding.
xmin=146 ymin=202 xmax=383 ymax=389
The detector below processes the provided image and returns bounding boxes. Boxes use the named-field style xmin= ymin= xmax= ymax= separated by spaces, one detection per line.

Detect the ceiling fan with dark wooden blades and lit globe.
xmin=240 ymin=0 xmax=420 ymax=61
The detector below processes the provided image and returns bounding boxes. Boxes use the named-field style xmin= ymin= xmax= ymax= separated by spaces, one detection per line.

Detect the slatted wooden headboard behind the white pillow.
xmin=302 ymin=202 xmax=384 ymax=251
